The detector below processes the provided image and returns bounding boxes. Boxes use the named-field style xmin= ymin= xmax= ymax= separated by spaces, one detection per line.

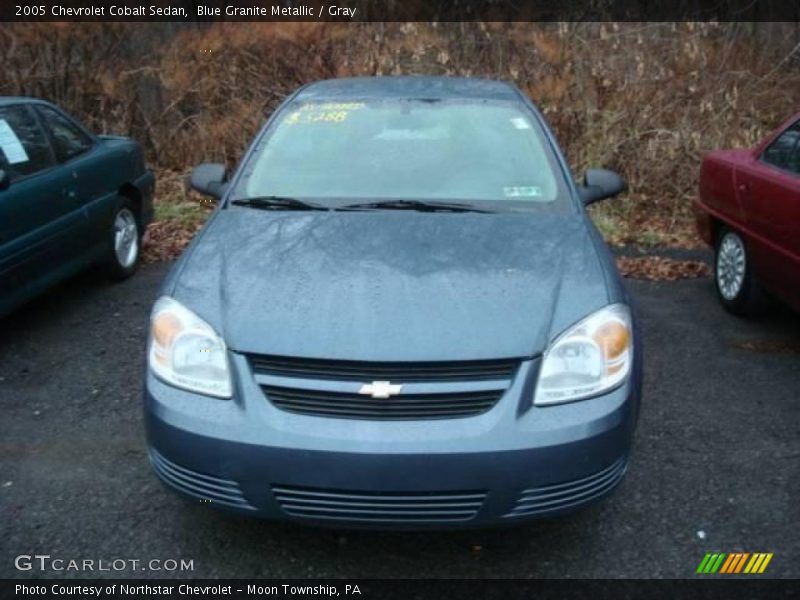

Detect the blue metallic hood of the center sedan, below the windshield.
xmin=168 ymin=208 xmax=616 ymax=361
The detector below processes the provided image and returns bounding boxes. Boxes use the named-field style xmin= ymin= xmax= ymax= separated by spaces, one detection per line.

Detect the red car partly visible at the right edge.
xmin=695 ymin=113 xmax=800 ymax=315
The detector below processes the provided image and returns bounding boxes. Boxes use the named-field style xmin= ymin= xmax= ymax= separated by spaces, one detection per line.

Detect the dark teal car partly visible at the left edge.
xmin=0 ymin=97 xmax=155 ymax=316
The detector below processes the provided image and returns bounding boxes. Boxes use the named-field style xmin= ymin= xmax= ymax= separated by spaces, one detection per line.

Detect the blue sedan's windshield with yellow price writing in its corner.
xmin=231 ymin=100 xmax=571 ymax=210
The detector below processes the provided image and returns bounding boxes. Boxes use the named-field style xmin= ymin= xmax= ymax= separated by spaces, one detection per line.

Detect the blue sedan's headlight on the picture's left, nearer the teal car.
xmin=147 ymin=296 xmax=231 ymax=398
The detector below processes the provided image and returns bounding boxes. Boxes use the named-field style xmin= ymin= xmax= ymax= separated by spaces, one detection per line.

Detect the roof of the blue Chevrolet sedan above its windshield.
xmin=296 ymin=75 xmax=520 ymax=100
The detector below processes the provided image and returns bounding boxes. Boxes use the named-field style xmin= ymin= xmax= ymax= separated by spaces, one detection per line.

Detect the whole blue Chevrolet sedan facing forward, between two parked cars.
xmin=144 ymin=77 xmax=641 ymax=528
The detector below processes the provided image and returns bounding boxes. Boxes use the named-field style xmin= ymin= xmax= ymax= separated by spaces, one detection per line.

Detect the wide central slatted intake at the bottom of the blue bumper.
xmin=272 ymin=484 xmax=486 ymax=523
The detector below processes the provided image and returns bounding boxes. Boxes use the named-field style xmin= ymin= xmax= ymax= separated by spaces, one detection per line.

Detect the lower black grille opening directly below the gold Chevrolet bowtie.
xmin=262 ymin=385 xmax=503 ymax=420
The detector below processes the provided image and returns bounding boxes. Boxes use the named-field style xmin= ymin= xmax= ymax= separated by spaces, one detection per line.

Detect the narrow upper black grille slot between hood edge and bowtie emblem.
xmin=248 ymin=354 xmax=519 ymax=383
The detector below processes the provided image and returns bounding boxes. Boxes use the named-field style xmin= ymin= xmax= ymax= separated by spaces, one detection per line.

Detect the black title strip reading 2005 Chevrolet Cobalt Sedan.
xmin=0 ymin=0 xmax=800 ymax=22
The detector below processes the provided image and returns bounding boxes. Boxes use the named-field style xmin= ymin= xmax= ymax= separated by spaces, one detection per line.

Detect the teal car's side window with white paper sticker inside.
xmin=0 ymin=104 xmax=54 ymax=181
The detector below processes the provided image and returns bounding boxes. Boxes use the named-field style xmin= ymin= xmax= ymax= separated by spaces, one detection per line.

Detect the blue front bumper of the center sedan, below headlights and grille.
xmin=145 ymin=354 xmax=641 ymax=528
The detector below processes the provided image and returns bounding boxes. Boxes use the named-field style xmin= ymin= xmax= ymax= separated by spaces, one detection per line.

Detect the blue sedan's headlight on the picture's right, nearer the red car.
xmin=534 ymin=304 xmax=633 ymax=405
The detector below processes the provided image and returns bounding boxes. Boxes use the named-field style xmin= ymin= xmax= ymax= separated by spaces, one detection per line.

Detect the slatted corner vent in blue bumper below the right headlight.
xmin=504 ymin=458 xmax=627 ymax=517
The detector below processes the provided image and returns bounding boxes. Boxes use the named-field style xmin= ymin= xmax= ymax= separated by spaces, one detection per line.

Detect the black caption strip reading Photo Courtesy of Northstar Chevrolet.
xmin=0 ymin=577 xmax=800 ymax=600
